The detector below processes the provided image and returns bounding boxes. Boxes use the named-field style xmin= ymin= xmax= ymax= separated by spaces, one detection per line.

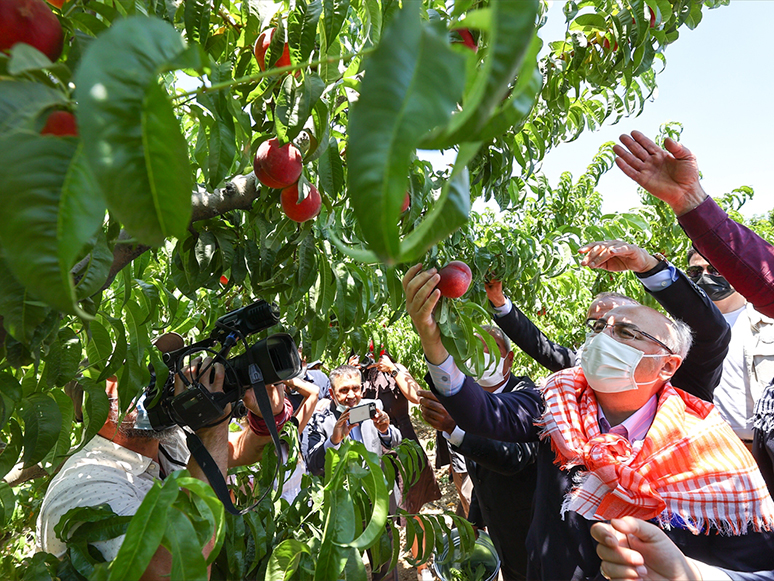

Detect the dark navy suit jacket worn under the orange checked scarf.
xmin=437 ymin=377 xmax=774 ymax=581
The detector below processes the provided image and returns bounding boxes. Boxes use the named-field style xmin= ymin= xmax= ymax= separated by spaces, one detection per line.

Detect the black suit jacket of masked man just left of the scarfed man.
xmin=452 ymin=375 xmax=537 ymax=581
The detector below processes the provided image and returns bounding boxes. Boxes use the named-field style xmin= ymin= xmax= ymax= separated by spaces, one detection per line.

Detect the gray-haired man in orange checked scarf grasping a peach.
xmin=403 ymin=265 xmax=774 ymax=580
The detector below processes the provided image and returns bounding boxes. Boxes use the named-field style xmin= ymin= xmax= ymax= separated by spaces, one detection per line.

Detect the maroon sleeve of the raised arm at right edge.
xmin=678 ymin=197 xmax=774 ymax=317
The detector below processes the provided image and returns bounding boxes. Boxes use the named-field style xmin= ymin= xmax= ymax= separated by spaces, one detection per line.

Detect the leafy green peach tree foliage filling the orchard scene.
xmin=0 ymin=0 xmax=728 ymax=579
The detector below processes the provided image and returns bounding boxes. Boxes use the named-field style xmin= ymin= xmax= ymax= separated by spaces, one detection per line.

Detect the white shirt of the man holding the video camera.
xmin=37 ymin=430 xmax=190 ymax=561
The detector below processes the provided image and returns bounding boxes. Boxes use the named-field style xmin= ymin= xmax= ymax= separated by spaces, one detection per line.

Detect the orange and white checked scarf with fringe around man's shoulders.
xmin=540 ymin=367 xmax=774 ymax=534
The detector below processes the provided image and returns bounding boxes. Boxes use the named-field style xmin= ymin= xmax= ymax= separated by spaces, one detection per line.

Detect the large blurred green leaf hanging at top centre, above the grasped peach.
xmin=347 ymin=2 xmax=464 ymax=263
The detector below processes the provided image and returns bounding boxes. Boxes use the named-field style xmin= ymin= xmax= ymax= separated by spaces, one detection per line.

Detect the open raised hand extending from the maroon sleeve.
xmin=613 ymin=131 xmax=707 ymax=216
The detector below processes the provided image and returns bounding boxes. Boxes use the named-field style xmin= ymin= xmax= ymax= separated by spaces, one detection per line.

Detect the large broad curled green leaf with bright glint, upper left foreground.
xmin=75 ymin=17 xmax=199 ymax=245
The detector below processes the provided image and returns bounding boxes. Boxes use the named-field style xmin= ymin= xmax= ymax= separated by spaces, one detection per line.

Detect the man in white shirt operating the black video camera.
xmin=37 ymin=357 xmax=290 ymax=581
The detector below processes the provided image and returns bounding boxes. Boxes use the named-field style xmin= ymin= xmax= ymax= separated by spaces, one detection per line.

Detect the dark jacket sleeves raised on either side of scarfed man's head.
xmin=495 ymin=270 xmax=731 ymax=402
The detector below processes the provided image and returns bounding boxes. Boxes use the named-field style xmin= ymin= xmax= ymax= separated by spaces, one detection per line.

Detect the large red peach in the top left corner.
xmin=0 ymin=0 xmax=64 ymax=61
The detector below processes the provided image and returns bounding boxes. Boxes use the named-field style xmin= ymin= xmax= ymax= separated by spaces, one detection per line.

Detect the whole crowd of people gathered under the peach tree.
xmin=33 ymin=132 xmax=774 ymax=581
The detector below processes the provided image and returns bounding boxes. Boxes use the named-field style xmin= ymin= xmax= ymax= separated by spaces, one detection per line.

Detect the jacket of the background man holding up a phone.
xmin=304 ymin=399 xmax=401 ymax=476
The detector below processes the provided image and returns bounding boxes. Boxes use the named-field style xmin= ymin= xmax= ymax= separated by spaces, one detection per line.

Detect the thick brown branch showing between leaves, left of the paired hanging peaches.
xmin=83 ymin=173 xmax=260 ymax=290
